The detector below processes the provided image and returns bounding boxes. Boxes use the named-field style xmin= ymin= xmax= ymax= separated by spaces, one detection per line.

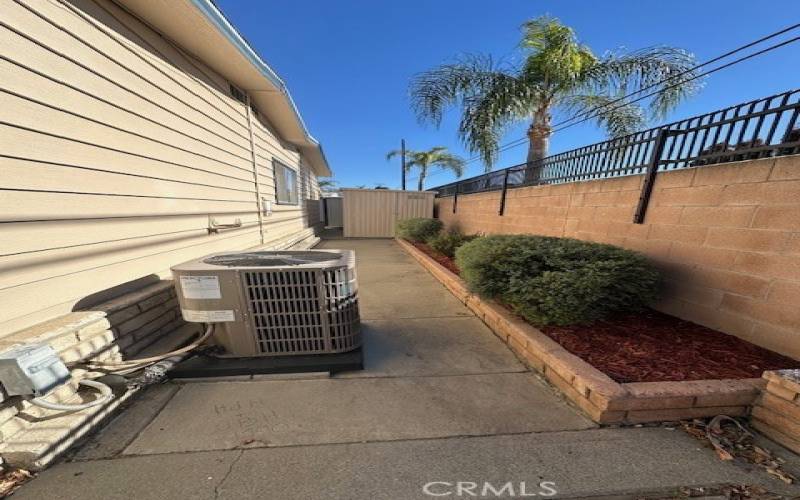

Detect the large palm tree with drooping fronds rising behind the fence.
xmin=410 ymin=16 xmax=700 ymax=176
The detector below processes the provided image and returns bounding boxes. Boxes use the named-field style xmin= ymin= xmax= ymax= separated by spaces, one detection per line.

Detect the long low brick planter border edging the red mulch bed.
xmin=397 ymin=239 xmax=764 ymax=424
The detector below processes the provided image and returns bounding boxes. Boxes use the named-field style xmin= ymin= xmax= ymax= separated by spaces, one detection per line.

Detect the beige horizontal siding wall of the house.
xmin=0 ymin=0 xmax=319 ymax=337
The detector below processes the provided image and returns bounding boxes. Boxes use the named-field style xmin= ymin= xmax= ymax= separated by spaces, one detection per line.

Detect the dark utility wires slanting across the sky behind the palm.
xmin=412 ymin=23 xmax=800 ymax=184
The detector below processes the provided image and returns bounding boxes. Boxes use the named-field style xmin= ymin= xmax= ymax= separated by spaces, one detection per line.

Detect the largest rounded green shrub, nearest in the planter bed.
xmin=456 ymin=235 xmax=659 ymax=325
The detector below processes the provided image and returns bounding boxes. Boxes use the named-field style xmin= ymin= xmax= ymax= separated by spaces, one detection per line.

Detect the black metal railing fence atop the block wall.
xmin=431 ymin=89 xmax=800 ymax=222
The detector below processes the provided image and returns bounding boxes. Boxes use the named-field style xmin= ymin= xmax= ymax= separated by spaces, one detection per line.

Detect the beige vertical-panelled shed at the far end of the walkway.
xmin=341 ymin=189 xmax=436 ymax=238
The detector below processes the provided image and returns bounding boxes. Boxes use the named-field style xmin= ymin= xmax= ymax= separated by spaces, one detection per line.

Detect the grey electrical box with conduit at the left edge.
xmin=0 ymin=344 xmax=71 ymax=397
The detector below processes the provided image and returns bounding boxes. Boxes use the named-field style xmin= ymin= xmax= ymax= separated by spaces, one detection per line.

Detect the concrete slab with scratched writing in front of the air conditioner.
xmin=124 ymin=373 xmax=594 ymax=454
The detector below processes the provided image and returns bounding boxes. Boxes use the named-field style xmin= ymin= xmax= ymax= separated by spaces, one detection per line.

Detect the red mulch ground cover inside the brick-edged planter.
xmin=412 ymin=243 xmax=800 ymax=383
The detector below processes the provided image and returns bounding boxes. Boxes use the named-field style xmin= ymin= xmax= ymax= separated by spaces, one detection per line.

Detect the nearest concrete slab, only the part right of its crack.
xmin=219 ymin=428 xmax=796 ymax=500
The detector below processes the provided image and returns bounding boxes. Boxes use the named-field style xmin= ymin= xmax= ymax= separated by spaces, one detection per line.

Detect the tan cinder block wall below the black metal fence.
xmin=436 ymin=155 xmax=800 ymax=359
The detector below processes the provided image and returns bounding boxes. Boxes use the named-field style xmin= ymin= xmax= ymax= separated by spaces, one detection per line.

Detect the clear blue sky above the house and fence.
xmin=217 ymin=0 xmax=800 ymax=188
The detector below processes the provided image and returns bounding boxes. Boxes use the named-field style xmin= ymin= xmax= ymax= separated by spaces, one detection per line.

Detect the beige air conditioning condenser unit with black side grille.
xmin=172 ymin=250 xmax=361 ymax=357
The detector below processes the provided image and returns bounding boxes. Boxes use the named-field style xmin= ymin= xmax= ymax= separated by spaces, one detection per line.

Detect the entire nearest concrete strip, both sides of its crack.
xmin=14 ymin=428 xmax=797 ymax=500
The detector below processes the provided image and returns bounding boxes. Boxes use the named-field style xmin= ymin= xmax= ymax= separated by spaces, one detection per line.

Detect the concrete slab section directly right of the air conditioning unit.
xmin=337 ymin=317 xmax=527 ymax=378
